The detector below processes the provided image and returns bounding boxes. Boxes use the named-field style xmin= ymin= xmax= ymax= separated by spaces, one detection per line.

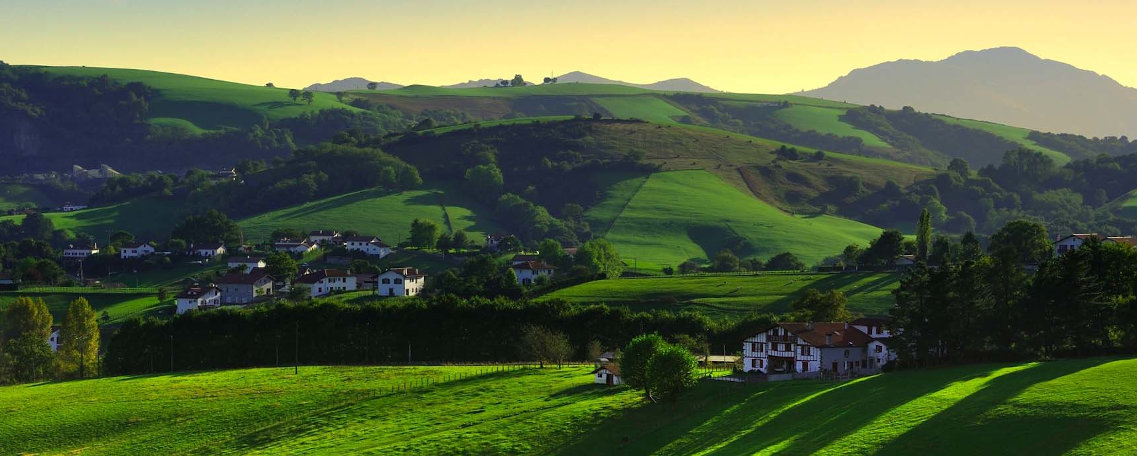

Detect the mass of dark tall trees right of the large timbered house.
xmin=890 ymin=221 xmax=1137 ymax=363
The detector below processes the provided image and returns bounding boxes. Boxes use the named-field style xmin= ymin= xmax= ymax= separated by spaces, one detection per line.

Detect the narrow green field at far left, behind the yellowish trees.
xmin=0 ymin=291 xmax=163 ymax=325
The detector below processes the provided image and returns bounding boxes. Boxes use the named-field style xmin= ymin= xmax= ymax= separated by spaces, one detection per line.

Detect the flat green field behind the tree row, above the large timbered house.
xmin=542 ymin=273 xmax=901 ymax=317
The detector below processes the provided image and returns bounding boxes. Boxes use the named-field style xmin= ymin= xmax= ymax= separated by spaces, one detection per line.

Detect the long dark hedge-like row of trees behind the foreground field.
xmin=103 ymin=297 xmax=772 ymax=374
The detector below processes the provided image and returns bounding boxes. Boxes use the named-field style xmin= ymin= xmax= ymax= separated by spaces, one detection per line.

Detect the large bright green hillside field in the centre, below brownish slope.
xmin=590 ymin=171 xmax=880 ymax=270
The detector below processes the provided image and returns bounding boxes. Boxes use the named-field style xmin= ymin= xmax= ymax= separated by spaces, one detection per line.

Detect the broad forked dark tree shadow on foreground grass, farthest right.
xmin=880 ymin=358 xmax=1113 ymax=455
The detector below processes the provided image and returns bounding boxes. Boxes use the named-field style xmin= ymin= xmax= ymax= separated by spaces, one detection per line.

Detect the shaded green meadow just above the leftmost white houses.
xmin=0 ymin=197 xmax=185 ymax=240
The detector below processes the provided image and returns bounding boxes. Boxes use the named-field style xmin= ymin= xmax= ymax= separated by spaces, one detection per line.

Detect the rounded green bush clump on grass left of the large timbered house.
xmin=620 ymin=333 xmax=698 ymax=401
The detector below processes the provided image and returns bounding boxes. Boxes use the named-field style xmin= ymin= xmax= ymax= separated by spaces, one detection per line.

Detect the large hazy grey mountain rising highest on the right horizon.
xmin=803 ymin=48 xmax=1137 ymax=138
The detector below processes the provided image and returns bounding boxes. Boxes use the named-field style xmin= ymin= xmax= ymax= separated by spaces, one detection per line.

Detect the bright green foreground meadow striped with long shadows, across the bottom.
xmin=0 ymin=358 xmax=1137 ymax=455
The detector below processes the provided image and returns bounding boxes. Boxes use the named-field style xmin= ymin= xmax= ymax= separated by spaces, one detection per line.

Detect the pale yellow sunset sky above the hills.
xmin=0 ymin=0 xmax=1137 ymax=93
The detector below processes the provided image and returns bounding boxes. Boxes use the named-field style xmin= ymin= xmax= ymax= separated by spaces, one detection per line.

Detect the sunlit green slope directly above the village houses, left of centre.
xmin=239 ymin=186 xmax=500 ymax=246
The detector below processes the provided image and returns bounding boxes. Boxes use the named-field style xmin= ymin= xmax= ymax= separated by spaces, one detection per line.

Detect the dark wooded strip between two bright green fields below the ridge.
xmin=669 ymin=94 xmax=864 ymax=155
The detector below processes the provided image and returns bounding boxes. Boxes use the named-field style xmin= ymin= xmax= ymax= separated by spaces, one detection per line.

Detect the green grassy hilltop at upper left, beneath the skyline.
xmin=41 ymin=67 xmax=356 ymax=132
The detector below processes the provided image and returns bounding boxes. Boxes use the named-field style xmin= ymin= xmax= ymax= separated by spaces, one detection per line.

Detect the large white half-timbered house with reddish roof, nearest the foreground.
xmin=742 ymin=320 xmax=896 ymax=380
